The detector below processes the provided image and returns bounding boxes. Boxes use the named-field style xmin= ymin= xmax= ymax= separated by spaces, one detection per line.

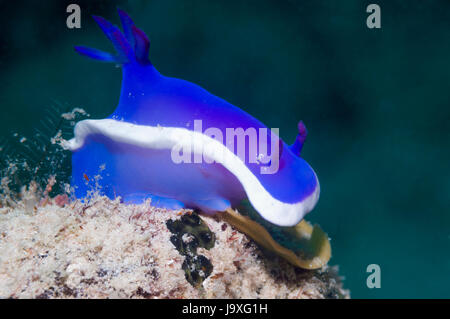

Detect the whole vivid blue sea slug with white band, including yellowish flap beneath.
xmin=67 ymin=9 xmax=330 ymax=268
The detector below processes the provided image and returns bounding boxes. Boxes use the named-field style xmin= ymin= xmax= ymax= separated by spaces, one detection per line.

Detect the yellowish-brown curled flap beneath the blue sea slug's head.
xmin=220 ymin=208 xmax=331 ymax=270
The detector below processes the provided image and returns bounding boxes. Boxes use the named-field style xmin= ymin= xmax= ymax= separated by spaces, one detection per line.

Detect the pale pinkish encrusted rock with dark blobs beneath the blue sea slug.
xmin=0 ymin=189 xmax=349 ymax=298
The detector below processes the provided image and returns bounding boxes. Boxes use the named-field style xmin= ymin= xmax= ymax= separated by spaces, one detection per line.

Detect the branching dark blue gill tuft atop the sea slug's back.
xmin=75 ymin=9 xmax=150 ymax=65
